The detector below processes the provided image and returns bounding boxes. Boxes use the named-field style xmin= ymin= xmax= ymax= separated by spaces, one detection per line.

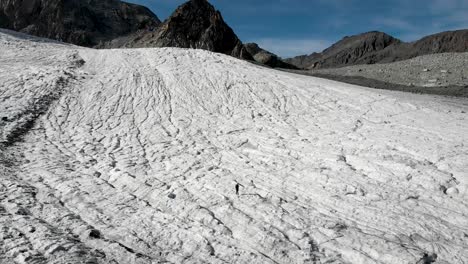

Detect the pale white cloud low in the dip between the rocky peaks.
xmin=247 ymin=38 xmax=332 ymax=58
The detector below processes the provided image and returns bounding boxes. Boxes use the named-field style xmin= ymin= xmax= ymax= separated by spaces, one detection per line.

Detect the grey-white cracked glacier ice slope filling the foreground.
xmin=0 ymin=29 xmax=468 ymax=264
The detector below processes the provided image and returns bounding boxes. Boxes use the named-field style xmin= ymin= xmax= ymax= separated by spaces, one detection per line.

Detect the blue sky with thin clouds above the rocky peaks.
xmin=127 ymin=0 xmax=468 ymax=57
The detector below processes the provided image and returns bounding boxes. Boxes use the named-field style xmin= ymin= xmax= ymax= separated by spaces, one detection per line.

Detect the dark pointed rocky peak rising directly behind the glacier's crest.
xmin=120 ymin=0 xmax=252 ymax=60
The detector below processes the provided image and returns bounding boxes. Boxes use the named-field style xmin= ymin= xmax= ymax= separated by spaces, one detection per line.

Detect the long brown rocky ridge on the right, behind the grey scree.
xmin=285 ymin=30 xmax=468 ymax=69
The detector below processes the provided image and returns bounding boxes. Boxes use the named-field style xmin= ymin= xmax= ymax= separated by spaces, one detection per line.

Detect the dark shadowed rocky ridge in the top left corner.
xmin=0 ymin=0 xmax=160 ymax=47
